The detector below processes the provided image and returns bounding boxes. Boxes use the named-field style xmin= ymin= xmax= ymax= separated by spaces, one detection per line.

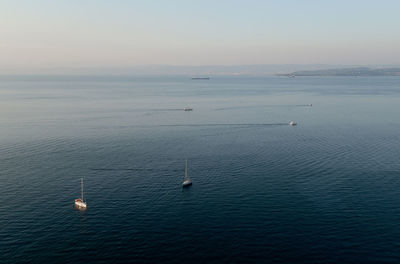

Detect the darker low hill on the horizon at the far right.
xmin=280 ymin=67 xmax=400 ymax=76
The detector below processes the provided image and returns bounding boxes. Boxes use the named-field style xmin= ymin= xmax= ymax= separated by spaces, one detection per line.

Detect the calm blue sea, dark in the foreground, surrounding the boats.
xmin=0 ymin=77 xmax=400 ymax=263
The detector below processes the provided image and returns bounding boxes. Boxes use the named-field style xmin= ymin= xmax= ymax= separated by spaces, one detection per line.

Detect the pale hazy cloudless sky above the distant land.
xmin=0 ymin=0 xmax=400 ymax=68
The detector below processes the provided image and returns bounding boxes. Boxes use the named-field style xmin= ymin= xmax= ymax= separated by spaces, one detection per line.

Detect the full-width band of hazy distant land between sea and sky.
xmin=0 ymin=64 xmax=400 ymax=77
